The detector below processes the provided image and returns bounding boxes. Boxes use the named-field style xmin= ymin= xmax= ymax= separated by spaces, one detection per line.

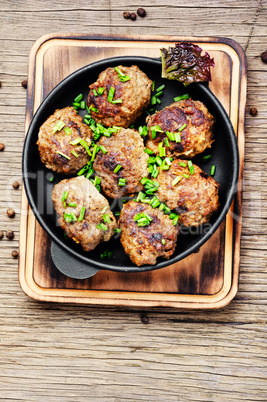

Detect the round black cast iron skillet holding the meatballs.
xmin=22 ymin=56 xmax=239 ymax=279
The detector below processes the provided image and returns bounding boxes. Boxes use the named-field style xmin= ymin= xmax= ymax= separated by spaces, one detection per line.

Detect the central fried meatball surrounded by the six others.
xmin=93 ymin=128 xmax=148 ymax=198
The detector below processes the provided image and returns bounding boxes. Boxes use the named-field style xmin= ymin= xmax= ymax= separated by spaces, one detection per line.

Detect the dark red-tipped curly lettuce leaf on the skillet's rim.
xmin=160 ymin=42 xmax=214 ymax=86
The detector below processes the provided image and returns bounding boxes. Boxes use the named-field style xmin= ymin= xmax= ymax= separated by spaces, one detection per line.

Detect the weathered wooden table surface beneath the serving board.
xmin=0 ymin=0 xmax=267 ymax=401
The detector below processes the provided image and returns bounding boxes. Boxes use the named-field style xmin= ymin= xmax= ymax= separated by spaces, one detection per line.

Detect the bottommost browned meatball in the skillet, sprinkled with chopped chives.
xmin=119 ymin=201 xmax=179 ymax=266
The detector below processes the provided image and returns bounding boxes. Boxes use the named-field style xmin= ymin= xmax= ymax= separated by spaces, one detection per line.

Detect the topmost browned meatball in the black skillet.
xmin=87 ymin=66 xmax=152 ymax=128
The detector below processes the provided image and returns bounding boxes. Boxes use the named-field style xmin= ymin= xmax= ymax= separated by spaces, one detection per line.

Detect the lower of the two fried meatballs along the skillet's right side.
xmin=156 ymin=159 xmax=220 ymax=226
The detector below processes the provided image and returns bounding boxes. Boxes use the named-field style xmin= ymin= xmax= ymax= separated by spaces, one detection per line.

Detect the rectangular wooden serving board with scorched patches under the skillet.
xmin=19 ymin=34 xmax=246 ymax=309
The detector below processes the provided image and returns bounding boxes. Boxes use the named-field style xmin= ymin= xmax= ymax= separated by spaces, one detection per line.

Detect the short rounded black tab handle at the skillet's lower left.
xmin=51 ymin=241 xmax=99 ymax=279
